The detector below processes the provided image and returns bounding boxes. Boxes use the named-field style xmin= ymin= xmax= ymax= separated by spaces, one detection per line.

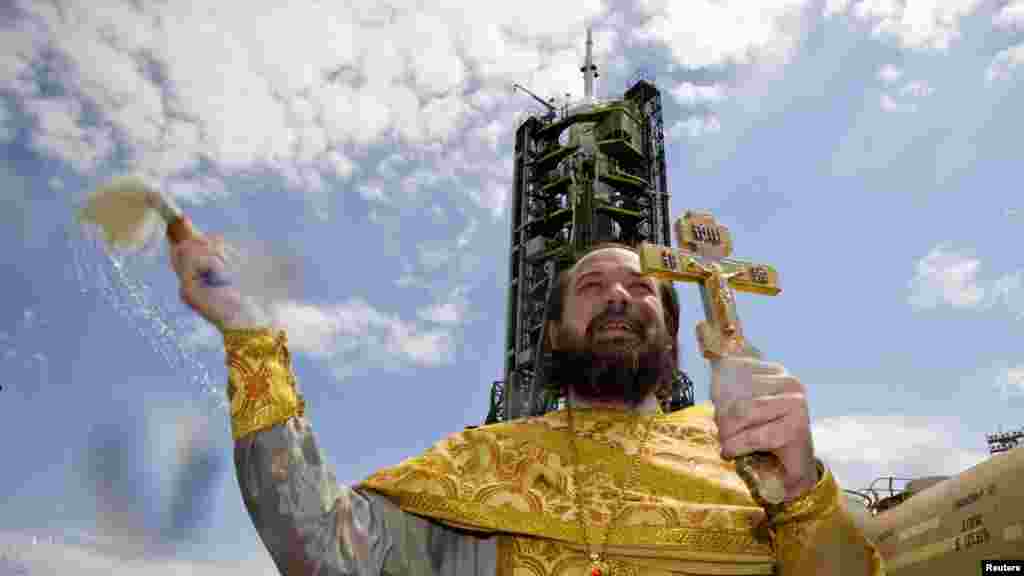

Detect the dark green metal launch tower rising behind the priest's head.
xmin=486 ymin=31 xmax=693 ymax=423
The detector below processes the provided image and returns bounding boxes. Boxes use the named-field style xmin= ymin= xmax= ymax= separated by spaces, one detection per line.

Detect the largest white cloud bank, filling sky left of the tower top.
xmin=0 ymin=0 xmax=606 ymax=218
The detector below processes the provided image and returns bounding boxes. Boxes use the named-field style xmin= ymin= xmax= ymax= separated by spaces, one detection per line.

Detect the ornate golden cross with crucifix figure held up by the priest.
xmin=640 ymin=211 xmax=785 ymax=505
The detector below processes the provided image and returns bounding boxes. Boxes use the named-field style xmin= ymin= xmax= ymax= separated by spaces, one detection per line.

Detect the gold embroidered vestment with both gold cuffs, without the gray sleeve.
xmin=224 ymin=330 xmax=885 ymax=576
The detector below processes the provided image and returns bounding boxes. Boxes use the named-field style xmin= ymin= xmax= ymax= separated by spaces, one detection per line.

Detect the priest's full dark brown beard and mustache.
xmin=550 ymin=311 xmax=675 ymax=408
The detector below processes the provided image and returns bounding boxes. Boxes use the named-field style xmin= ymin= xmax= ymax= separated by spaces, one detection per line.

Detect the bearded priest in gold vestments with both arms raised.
xmin=172 ymin=229 xmax=885 ymax=576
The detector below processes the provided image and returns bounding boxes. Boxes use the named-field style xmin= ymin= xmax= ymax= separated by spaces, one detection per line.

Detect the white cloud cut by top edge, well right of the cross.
xmin=824 ymin=0 xmax=984 ymax=51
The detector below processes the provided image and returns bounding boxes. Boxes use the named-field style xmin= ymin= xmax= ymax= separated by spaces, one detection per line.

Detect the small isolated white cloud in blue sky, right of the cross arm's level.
xmin=909 ymin=245 xmax=985 ymax=310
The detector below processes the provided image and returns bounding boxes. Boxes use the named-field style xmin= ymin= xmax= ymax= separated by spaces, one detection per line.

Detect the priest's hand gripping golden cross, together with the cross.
xmin=640 ymin=212 xmax=818 ymax=506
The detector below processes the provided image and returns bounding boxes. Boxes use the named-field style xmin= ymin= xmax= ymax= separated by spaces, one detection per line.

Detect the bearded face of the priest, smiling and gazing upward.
xmin=551 ymin=248 xmax=674 ymax=407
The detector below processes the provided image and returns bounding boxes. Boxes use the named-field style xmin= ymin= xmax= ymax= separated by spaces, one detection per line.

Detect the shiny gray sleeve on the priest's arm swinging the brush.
xmin=234 ymin=417 xmax=497 ymax=576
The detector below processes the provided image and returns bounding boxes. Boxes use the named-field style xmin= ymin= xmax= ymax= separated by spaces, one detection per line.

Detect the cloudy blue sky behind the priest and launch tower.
xmin=0 ymin=0 xmax=1024 ymax=574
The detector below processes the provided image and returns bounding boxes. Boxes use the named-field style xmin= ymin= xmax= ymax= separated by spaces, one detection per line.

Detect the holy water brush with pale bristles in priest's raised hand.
xmin=79 ymin=172 xmax=227 ymax=286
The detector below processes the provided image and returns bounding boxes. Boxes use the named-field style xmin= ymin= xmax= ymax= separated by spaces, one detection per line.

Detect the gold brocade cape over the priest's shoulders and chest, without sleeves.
xmin=360 ymin=405 xmax=811 ymax=576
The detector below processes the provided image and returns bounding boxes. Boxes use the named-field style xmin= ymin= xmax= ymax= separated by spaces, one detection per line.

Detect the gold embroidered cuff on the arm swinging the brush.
xmin=223 ymin=328 xmax=305 ymax=440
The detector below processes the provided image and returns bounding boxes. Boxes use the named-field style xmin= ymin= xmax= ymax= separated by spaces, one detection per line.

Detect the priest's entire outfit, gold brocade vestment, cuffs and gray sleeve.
xmin=224 ymin=329 xmax=885 ymax=576
